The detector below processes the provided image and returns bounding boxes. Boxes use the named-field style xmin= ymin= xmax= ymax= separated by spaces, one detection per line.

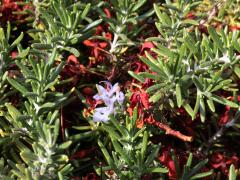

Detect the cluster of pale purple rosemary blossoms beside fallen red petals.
xmin=93 ymin=81 xmax=124 ymax=122
